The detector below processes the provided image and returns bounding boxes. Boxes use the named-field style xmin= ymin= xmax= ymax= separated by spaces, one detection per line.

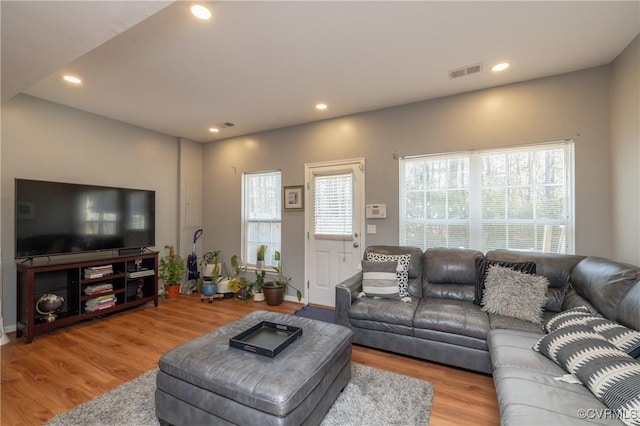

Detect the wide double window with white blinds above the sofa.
xmin=400 ymin=142 xmax=575 ymax=253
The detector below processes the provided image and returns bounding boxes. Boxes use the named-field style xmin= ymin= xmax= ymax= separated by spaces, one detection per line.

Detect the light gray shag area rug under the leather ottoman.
xmin=47 ymin=363 xmax=433 ymax=426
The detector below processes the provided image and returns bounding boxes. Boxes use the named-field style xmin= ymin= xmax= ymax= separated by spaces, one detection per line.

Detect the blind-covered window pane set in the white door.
xmin=312 ymin=170 xmax=353 ymax=239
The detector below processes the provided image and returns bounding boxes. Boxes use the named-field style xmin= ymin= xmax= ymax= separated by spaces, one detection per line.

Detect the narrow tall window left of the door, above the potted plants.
xmin=242 ymin=171 xmax=282 ymax=266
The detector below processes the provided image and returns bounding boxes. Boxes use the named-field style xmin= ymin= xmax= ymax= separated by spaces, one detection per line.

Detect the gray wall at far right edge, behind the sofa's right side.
xmin=611 ymin=35 xmax=640 ymax=265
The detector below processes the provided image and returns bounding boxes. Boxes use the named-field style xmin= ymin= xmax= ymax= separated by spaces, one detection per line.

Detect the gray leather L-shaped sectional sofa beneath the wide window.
xmin=335 ymin=246 xmax=640 ymax=425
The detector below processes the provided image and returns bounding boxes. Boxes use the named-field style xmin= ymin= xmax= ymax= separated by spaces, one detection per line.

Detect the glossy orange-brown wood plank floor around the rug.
xmin=0 ymin=296 xmax=499 ymax=426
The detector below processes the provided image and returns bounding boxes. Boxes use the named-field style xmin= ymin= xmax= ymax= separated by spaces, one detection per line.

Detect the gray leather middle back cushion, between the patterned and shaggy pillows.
xmin=422 ymin=247 xmax=484 ymax=301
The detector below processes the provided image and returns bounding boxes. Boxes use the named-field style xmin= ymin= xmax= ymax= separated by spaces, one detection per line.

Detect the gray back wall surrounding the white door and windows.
xmin=203 ymin=65 xmax=612 ymax=302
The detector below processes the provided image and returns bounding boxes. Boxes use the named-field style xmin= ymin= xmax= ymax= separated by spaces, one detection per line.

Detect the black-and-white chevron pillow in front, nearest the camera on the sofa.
xmin=533 ymin=324 xmax=640 ymax=426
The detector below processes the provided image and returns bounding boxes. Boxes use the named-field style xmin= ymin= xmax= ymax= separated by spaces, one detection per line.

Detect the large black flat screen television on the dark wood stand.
xmin=15 ymin=179 xmax=156 ymax=258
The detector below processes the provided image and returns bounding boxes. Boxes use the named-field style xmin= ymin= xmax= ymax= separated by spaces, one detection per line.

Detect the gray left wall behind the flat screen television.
xmin=1 ymin=95 xmax=185 ymax=330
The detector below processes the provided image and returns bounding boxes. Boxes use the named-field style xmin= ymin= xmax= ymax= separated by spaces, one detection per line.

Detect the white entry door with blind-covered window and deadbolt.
xmin=305 ymin=159 xmax=364 ymax=307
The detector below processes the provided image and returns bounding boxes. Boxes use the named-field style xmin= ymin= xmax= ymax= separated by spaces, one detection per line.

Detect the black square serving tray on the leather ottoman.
xmin=229 ymin=321 xmax=302 ymax=358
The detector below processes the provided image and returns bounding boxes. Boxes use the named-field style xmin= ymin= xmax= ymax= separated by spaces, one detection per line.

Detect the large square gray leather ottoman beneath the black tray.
xmin=156 ymin=311 xmax=352 ymax=425
